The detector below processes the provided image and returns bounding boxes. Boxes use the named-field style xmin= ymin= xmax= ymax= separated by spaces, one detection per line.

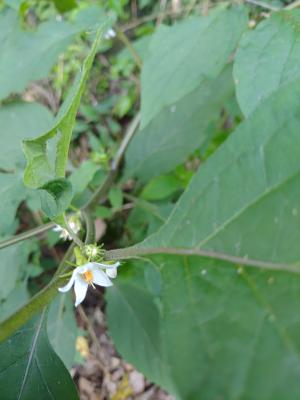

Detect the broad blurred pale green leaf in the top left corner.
xmin=0 ymin=8 xmax=104 ymax=99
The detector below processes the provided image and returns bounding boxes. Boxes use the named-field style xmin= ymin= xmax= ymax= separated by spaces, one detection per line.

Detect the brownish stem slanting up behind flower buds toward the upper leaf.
xmin=82 ymin=113 xmax=140 ymax=211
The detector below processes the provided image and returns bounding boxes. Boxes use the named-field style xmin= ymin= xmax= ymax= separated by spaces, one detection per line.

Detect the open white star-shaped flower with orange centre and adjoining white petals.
xmin=58 ymin=262 xmax=120 ymax=307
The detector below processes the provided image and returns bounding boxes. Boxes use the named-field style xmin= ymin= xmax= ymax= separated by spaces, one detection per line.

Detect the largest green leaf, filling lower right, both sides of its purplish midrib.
xmin=108 ymin=79 xmax=300 ymax=400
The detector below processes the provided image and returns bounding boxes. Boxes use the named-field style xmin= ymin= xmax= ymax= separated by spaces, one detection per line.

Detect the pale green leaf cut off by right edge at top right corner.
xmin=233 ymin=10 xmax=300 ymax=116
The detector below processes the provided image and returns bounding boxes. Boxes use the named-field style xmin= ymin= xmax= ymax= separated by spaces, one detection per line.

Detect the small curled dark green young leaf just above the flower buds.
xmin=39 ymin=179 xmax=73 ymax=219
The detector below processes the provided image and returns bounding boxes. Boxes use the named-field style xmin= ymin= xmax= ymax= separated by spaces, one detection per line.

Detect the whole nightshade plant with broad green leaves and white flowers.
xmin=0 ymin=2 xmax=300 ymax=400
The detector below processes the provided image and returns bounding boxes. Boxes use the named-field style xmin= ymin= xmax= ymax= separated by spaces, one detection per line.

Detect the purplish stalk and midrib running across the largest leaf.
xmin=105 ymin=246 xmax=300 ymax=274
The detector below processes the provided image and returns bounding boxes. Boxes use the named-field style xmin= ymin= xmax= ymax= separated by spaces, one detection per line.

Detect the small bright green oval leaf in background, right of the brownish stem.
xmin=141 ymin=175 xmax=182 ymax=200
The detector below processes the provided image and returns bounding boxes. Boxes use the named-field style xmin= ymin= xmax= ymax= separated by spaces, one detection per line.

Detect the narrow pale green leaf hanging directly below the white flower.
xmin=47 ymin=293 xmax=78 ymax=369
